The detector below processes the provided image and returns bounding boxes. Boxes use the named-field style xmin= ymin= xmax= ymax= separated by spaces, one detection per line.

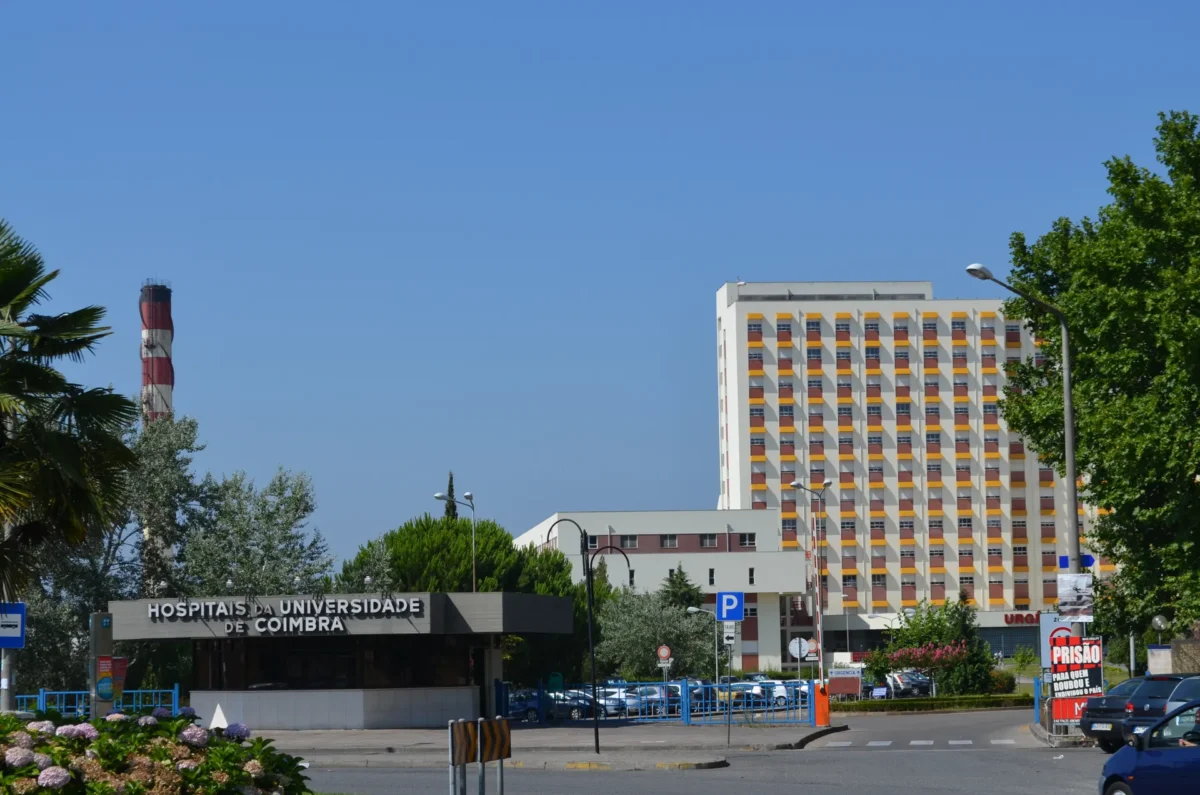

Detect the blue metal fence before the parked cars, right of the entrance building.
xmin=496 ymin=680 xmax=815 ymax=725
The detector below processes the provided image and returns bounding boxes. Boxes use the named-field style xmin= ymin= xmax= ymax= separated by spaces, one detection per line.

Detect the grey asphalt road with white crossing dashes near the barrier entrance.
xmin=304 ymin=712 xmax=1106 ymax=795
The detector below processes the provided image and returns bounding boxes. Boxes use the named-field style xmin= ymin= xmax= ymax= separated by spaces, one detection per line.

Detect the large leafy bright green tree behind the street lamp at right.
xmin=1002 ymin=112 xmax=1200 ymax=636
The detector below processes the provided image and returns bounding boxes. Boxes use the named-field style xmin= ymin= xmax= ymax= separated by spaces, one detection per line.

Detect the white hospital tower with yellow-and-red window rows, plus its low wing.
xmin=518 ymin=282 xmax=1112 ymax=670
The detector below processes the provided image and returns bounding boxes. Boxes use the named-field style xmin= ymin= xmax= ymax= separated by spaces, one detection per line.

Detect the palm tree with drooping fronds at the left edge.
xmin=0 ymin=220 xmax=137 ymax=598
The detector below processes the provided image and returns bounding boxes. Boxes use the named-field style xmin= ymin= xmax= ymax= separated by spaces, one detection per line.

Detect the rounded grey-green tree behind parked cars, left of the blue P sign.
xmin=596 ymin=590 xmax=713 ymax=681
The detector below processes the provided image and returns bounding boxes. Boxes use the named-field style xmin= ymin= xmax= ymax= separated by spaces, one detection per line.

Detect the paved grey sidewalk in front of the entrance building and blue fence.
xmin=263 ymin=722 xmax=846 ymax=770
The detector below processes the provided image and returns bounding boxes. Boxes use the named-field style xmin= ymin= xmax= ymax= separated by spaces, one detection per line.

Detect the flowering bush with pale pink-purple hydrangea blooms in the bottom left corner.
xmin=0 ymin=711 xmax=307 ymax=795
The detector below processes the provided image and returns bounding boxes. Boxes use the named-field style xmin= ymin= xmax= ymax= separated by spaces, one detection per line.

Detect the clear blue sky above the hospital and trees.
xmin=0 ymin=1 xmax=1200 ymax=564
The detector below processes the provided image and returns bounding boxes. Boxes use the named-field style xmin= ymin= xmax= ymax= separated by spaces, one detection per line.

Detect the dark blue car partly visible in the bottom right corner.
xmin=1099 ymin=700 xmax=1200 ymax=795
